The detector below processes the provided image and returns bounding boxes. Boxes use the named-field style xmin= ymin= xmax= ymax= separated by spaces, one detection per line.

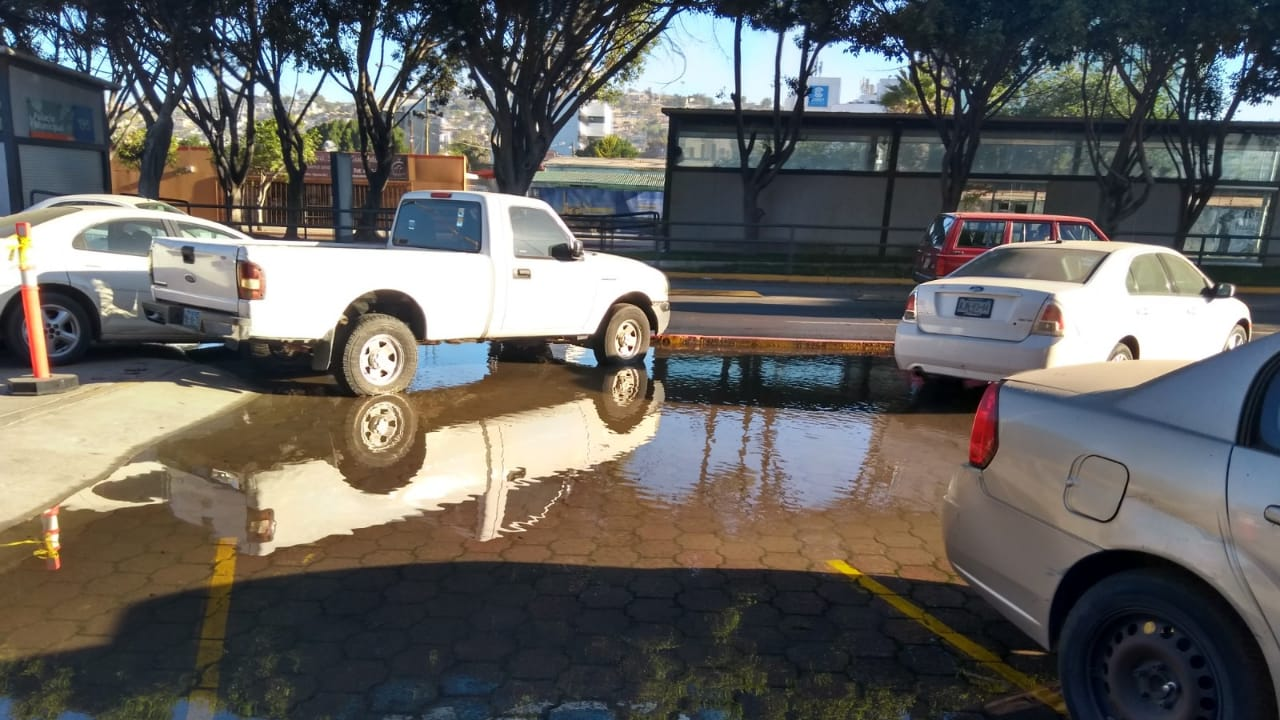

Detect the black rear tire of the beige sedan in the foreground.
xmin=1057 ymin=570 xmax=1276 ymax=720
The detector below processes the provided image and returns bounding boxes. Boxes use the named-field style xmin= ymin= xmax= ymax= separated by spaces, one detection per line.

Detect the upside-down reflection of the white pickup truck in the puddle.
xmin=64 ymin=364 xmax=663 ymax=555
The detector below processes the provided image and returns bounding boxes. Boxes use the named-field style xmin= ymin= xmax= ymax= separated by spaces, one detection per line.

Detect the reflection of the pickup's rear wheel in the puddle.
xmin=337 ymin=395 xmax=426 ymax=495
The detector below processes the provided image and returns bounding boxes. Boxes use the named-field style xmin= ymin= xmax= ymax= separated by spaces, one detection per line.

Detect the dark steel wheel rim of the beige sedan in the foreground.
xmin=1091 ymin=616 xmax=1221 ymax=720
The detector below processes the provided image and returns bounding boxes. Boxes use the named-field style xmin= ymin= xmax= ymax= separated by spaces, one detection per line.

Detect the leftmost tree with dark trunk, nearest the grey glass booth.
xmin=82 ymin=0 xmax=215 ymax=197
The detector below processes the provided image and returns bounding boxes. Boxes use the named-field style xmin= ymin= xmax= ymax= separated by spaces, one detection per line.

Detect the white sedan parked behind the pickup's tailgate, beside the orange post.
xmin=0 ymin=205 xmax=248 ymax=365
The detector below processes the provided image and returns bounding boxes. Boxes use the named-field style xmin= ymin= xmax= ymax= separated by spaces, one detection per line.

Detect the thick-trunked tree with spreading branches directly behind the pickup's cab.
xmin=444 ymin=0 xmax=677 ymax=195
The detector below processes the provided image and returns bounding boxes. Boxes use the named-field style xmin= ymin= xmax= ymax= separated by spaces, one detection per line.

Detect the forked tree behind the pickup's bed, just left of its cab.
xmin=316 ymin=0 xmax=456 ymax=238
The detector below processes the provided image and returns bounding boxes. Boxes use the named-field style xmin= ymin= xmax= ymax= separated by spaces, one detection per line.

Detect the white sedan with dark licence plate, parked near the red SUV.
xmin=893 ymin=242 xmax=1253 ymax=380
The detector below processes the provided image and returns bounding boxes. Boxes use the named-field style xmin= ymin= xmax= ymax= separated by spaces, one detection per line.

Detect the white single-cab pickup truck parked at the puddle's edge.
xmin=143 ymin=191 xmax=671 ymax=395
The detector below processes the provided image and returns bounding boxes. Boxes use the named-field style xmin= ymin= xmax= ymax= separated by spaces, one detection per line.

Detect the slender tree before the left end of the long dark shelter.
xmin=713 ymin=0 xmax=860 ymax=241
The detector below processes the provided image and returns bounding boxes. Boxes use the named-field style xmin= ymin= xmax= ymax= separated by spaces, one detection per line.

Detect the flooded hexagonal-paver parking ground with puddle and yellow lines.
xmin=0 ymin=346 xmax=1059 ymax=720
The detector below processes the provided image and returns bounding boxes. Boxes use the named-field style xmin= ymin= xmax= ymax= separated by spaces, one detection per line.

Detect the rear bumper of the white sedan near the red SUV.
xmin=893 ymin=322 xmax=1085 ymax=382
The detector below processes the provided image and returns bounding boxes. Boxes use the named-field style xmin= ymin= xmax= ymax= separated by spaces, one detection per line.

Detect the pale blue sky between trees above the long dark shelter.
xmin=631 ymin=14 xmax=1280 ymax=122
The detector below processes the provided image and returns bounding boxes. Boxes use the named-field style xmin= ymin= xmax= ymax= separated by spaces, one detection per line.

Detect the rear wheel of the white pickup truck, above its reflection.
xmin=333 ymin=313 xmax=417 ymax=396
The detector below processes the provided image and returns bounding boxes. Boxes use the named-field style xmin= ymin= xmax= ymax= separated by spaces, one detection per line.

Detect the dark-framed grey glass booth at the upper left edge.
xmin=0 ymin=46 xmax=113 ymax=210
